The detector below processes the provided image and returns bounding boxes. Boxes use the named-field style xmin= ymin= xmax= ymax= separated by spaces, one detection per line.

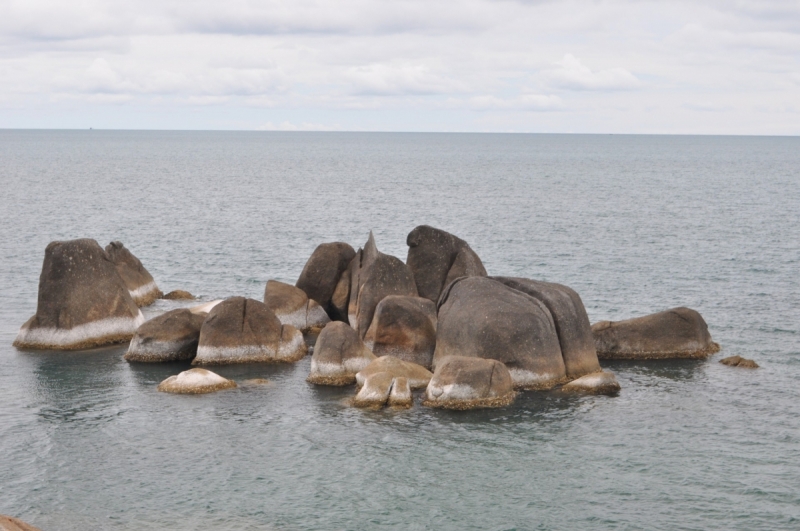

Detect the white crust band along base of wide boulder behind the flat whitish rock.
xmin=192 ymin=325 xmax=308 ymax=365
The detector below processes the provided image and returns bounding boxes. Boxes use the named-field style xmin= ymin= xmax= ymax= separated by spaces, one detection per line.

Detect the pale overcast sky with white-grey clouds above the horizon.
xmin=0 ymin=0 xmax=800 ymax=135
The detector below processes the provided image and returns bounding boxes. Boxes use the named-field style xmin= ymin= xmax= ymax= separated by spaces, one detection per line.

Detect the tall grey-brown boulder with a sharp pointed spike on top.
xmin=347 ymin=231 xmax=417 ymax=339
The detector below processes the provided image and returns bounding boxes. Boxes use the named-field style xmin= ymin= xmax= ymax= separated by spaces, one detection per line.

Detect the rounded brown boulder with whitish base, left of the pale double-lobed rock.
xmin=306 ymin=321 xmax=376 ymax=385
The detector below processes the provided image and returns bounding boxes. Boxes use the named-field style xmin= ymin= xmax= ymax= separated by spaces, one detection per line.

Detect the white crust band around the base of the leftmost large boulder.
xmin=14 ymin=311 xmax=145 ymax=350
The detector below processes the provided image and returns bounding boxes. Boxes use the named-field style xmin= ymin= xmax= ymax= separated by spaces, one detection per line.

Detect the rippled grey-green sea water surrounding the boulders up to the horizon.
xmin=0 ymin=131 xmax=800 ymax=531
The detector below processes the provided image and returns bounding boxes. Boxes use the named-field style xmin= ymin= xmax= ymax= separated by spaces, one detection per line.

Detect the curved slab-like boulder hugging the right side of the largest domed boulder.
xmin=492 ymin=277 xmax=600 ymax=378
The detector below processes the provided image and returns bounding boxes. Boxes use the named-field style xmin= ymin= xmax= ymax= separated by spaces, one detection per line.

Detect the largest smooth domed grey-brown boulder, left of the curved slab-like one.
xmin=433 ymin=277 xmax=567 ymax=389
